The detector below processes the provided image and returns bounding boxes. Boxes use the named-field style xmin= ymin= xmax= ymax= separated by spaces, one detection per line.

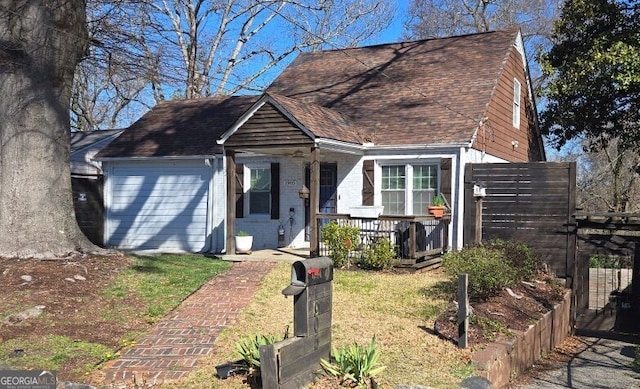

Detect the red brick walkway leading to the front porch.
xmin=103 ymin=262 xmax=276 ymax=384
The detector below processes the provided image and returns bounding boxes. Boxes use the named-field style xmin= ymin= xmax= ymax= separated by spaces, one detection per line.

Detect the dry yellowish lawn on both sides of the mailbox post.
xmin=164 ymin=263 xmax=473 ymax=389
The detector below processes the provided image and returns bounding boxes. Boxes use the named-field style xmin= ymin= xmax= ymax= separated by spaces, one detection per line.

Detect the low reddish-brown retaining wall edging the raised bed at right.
xmin=472 ymin=292 xmax=571 ymax=389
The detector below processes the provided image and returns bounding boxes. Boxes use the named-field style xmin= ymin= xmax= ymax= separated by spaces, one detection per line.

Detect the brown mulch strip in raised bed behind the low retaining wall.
xmin=435 ymin=277 xmax=566 ymax=347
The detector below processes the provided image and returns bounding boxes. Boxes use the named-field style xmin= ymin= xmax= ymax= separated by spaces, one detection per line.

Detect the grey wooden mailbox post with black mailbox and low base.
xmin=260 ymin=257 xmax=333 ymax=389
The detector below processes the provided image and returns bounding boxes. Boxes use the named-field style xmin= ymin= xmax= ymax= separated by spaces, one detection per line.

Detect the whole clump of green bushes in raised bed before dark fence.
xmin=442 ymin=240 xmax=540 ymax=300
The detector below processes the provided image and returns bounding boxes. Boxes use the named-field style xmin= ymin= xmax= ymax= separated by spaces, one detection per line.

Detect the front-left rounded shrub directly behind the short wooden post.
xmin=442 ymin=246 xmax=519 ymax=299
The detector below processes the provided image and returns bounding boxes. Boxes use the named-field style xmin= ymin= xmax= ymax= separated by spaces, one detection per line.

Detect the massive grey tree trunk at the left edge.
xmin=0 ymin=0 xmax=95 ymax=258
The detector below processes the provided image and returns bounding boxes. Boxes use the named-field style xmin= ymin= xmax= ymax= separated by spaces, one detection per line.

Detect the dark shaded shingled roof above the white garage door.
xmin=97 ymin=96 xmax=260 ymax=158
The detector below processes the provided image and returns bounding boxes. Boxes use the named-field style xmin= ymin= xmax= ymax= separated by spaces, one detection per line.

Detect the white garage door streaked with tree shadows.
xmin=105 ymin=160 xmax=211 ymax=252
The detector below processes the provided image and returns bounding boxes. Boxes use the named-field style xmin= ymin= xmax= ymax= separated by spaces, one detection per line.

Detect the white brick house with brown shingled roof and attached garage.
xmin=98 ymin=31 xmax=545 ymax=252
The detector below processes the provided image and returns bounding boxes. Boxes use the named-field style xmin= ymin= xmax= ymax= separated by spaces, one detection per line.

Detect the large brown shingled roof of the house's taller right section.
xmin=267 ymin=31 xmax=518 ymax=145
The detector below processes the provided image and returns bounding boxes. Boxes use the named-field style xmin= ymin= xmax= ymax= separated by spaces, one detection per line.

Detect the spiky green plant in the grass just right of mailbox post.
xmin=320 ymin=336 xmax=386 ymax=386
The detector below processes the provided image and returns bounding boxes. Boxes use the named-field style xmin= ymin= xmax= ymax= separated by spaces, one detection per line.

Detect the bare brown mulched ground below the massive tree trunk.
xmin=0 ymin=255 xmax=149 ymax=381
